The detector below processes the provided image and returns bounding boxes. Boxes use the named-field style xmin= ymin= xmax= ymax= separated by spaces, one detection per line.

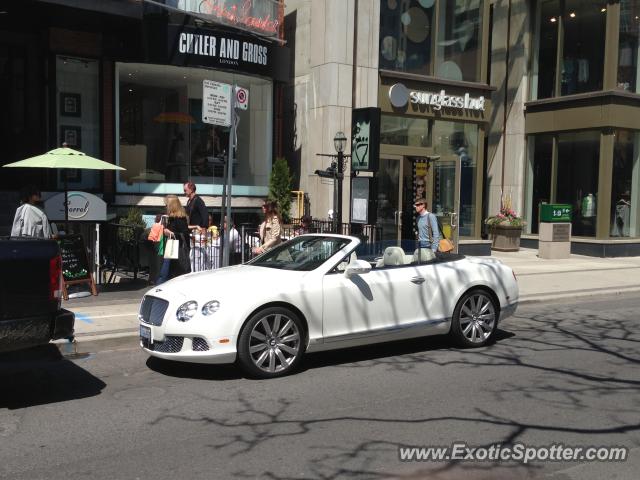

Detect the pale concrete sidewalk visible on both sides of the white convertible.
xmin=58 ymin=248 xmax=640 ymax=354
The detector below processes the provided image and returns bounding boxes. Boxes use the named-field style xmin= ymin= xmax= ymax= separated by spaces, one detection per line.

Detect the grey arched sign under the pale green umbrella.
xmin=44 ymin=192 xmax=107 ymax=222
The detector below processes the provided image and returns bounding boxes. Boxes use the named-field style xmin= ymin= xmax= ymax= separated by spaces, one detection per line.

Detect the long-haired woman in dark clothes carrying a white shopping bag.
xmin=156 ymin=195 xmax=191 ymax=284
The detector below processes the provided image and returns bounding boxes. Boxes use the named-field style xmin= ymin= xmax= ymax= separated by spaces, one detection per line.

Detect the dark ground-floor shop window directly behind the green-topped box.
xmin=556 ymin=131 xmax=600 ymax=237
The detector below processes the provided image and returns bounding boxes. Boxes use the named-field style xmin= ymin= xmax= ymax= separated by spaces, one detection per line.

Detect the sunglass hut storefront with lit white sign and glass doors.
xmin=377 ymin=71 xmax=492 ymax=255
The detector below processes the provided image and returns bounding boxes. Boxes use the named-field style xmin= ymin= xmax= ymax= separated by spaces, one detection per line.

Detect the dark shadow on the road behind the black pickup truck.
xmin=0 ymin=344 xmax=106 ymax=409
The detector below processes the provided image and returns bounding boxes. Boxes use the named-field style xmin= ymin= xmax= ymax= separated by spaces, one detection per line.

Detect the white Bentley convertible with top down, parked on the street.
xmin=138 ymin=234 xmax=519 ymax=378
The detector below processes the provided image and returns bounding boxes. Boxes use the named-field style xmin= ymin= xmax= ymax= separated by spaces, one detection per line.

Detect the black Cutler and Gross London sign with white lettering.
xmin=168 ymin=26 xmax=274 ymax=76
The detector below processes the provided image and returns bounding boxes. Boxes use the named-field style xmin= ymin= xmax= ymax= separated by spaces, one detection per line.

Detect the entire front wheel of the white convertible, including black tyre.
xmin=238 ymin=307 xmax=305 ymax=378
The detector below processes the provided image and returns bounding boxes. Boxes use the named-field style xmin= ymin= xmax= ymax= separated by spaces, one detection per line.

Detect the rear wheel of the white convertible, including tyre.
xmin=451 ymin=289 xmax=498 ymax=347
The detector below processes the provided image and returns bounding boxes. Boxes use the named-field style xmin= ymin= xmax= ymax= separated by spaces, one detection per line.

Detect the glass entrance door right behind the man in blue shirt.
xmin=428 ymin=155 xmax=461 ymax=253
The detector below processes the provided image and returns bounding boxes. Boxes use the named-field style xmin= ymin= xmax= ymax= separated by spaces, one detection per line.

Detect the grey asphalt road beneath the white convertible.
xmin=0 ymin=296 xmax=640 ymax=480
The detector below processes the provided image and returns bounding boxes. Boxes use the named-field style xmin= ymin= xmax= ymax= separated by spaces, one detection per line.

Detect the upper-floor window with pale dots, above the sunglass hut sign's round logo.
xmin=380 ymin=0 xmax=435 ymax=75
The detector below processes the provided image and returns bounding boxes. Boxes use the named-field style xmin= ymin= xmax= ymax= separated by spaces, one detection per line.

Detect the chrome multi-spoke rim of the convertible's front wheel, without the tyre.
xmin=249 ymin=313 xmax=301 ymax=373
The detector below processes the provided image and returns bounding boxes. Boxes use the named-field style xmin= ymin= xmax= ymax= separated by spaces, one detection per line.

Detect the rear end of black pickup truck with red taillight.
xmin=0 ymin=238 xmax=75 ymax=352
